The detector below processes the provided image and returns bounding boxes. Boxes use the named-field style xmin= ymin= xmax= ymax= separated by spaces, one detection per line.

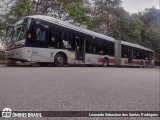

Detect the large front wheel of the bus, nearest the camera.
xmin=54 ymin=53 xmax=66 ymax=67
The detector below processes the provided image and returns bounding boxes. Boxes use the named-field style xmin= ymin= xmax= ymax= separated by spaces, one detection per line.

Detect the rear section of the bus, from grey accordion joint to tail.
xmin=115 ymin=41 xmax=154 ymax=67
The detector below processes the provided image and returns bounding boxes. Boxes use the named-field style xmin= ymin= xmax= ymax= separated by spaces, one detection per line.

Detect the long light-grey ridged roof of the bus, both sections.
xmin=27 ymin=15 xmax=153 ymax=52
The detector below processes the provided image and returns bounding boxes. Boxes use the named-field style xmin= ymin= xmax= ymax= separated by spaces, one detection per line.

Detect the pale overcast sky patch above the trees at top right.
xmin=121 ymin=0 xmax=160 ymax=13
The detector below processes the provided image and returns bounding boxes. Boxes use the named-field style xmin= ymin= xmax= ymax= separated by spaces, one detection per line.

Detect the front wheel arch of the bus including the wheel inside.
xmin=54 ymin=52 xmax=68 ymax=67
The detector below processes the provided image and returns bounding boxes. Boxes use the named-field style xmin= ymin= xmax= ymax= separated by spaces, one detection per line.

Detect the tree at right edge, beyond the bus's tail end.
xmin=138 ymin=7 xmax=160 ymax=59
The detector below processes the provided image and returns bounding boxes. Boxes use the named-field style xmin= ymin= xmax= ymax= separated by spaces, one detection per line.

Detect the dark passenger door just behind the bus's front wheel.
xmin=75 ymin=36 xmax=85 ymax=62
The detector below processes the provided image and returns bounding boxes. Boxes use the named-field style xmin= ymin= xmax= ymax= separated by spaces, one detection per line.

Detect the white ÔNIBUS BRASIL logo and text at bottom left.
xmin=2 ymin=108 xmax=42 ymax=118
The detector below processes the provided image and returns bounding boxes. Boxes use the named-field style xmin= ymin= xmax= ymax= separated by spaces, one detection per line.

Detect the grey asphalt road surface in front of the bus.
xmin=0 ymin=66 xmax=160 ymax=120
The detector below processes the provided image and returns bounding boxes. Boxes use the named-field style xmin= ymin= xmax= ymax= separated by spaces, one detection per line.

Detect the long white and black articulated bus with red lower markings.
xmin=6 ymin=15 xmax=154 ymax=67
